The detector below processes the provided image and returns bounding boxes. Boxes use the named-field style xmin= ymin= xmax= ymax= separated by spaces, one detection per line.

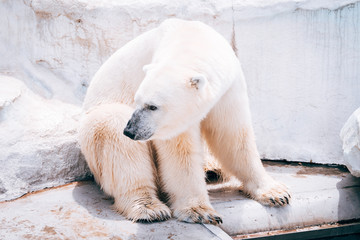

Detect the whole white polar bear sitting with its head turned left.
xmin=79 ymin=19 xmax=290 ymax=224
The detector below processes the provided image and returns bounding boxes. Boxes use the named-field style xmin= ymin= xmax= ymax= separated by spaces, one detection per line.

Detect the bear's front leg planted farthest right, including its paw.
xmin=201 ymin=82 xmax=290 ymax=206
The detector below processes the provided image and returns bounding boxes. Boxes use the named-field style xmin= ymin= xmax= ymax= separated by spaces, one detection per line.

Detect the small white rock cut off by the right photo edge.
xmin=340 ymin=108 xmax=360 ymax=177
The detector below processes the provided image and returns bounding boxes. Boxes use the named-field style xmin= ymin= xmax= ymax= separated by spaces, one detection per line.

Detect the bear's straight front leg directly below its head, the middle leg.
xmin=154 ymin=127 xmax=222 ymax=224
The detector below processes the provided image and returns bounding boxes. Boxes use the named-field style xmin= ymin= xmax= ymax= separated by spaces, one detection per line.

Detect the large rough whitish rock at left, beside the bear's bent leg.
xmin=0 ymin=76 xmax=89 ymax=201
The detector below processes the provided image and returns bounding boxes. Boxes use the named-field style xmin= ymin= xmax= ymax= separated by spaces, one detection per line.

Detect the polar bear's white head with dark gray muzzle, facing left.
xmin=124 ymin=65 xmax=212 ymax=141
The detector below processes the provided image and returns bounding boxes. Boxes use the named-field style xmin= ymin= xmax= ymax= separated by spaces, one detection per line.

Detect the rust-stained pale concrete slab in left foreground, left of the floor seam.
xmin=0 ymin=182 xmax=223 ymax=240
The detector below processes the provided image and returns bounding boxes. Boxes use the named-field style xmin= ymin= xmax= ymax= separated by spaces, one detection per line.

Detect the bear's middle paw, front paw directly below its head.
xmin=174 ymin=205 xmax=222 ymax=225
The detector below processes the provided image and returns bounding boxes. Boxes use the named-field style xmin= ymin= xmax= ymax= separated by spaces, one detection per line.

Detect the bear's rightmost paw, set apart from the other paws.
xmin=245 ymin=179 xmax=291 ymax=207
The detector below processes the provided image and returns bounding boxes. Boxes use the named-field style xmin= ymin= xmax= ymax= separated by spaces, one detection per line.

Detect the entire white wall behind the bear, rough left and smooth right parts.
xmin=0 ymin=0 xmax=360 ymax=164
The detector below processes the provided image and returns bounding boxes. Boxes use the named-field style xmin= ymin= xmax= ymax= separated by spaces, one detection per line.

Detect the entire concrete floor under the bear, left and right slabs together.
xmin=0 ymin=162 xmax=360 ymax=239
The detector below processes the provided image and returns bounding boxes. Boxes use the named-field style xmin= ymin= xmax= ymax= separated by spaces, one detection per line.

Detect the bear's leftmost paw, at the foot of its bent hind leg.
xmin=121 ymin=201 xmax=171 ymax=223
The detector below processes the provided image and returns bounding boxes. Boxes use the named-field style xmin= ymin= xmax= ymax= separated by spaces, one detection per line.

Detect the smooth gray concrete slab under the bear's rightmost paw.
xmin=210 ymin=161 xmax=360 ymax=236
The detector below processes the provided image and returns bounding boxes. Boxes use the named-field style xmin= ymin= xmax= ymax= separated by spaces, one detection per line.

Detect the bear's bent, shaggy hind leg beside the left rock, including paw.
xmin=79 ymin=104 xmax=171 ymax=222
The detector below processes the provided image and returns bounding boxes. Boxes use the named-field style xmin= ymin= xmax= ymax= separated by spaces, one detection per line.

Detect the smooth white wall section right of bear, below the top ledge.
xmin=236 ymin=3 xmax=360 ymax=163
